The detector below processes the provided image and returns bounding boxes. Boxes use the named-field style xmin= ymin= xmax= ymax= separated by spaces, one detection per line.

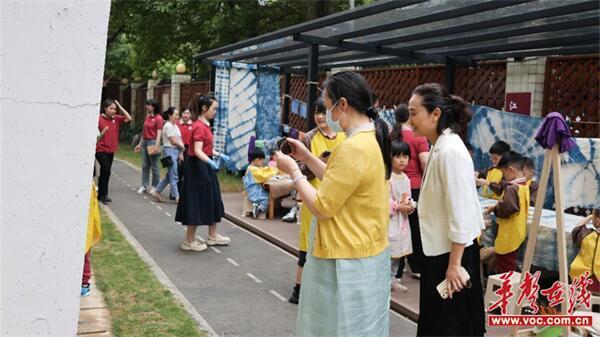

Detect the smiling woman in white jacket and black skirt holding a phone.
xmin=409 ymin=83 xmax=485 ymax=336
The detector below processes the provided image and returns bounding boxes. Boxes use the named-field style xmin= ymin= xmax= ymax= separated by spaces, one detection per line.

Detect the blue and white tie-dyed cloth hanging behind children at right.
xmin=468 ymin=105 xmax=600 ymax=208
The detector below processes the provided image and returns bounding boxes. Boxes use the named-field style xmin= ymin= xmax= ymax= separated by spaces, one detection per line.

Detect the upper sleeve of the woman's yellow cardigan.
xmin=315 ymin=142 xmax=367 ymax=218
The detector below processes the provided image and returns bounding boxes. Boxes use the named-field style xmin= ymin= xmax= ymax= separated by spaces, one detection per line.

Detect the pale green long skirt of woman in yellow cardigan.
xmin=296 ymin=219 xmax=391 ymax=337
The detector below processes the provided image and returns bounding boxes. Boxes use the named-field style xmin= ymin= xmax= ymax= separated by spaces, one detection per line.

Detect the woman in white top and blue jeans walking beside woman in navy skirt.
xmin=150 ymin=107 xmax=184 ymax=201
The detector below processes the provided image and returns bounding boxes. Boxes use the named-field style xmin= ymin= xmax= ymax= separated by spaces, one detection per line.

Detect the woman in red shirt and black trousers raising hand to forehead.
xmin=96 ymin=98 xmax=131 ymax=204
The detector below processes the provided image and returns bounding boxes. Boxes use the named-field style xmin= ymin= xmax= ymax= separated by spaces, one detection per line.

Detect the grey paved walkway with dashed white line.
xmin=110 ymin=161 xmax=416 ymax=337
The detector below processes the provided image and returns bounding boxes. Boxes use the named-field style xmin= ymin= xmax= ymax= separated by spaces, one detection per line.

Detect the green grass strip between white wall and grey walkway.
xmin=92 ymin=213 xmax=206 ymax=337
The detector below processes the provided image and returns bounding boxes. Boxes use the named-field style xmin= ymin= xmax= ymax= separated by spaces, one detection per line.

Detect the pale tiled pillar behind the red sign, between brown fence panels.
xmin=506 ymin=57 xmax=546 ymax=117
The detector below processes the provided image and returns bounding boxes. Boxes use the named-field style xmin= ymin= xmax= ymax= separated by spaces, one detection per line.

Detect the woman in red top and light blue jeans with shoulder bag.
xmin=135 ymin=99 xmax=164 ymax=194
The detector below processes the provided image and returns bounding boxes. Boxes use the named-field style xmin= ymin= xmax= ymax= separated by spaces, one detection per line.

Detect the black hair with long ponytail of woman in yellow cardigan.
xmin=324 ymin=71 xmax=392 ymax=179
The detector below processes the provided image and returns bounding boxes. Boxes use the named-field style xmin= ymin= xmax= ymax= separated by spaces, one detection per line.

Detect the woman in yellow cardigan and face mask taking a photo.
xmin=277 ymin=71 xmax=391 ymax=337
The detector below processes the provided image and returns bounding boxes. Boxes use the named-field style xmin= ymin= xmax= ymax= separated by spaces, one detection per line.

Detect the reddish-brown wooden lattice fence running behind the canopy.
xmin=111 ymin=55 xmax=600 ymax=137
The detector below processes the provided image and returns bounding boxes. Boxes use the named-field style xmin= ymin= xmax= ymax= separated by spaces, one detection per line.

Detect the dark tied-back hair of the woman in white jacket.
xmin=412 ymin=83 xmax=473 ymax=141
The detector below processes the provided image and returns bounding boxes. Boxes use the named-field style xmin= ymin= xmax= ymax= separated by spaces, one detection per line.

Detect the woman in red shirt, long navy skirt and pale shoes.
xmin=175 ymin=96 xmax=231 ymax=252
